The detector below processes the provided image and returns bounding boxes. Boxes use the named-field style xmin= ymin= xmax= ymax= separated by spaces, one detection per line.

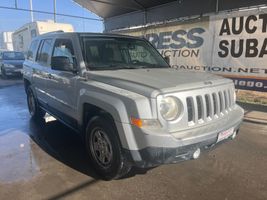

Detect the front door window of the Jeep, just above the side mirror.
xmin=53 ymin=39 xmax=74 ymax=63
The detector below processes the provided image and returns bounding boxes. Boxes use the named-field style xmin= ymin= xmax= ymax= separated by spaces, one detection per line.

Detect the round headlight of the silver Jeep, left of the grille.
xmin=159 ymin=97 xmax=181 ymax=121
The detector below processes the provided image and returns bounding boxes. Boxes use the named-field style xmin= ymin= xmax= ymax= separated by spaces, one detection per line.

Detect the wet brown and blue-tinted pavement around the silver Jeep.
xmin=0 ymin=80 xmax=267 ymax=200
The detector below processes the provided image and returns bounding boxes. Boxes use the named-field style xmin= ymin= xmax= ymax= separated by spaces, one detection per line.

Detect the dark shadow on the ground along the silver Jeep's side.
xmin=29 ymin=116 xmax=97 ymax=178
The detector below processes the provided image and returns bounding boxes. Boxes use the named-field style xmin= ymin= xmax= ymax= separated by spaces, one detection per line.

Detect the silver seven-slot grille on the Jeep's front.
xmin=186 ymin=89 xmax=234 ymax=125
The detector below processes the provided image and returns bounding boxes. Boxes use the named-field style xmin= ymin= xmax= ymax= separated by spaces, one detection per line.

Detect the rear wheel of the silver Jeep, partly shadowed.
xmin=27 ymin=86 xmax=45 ymax=120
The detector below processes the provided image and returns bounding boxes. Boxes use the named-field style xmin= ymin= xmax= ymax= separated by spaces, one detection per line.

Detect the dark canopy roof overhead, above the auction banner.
xmin=73 ymin=0 xmax=267 ymax=32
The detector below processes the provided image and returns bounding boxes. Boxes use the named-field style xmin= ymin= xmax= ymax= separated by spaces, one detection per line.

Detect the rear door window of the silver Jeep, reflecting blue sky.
xmin=37 ymin=39 xmax=52 ymax=66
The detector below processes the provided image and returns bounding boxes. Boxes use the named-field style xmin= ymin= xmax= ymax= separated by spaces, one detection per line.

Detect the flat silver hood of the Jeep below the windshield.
xmin=87 ymin=68 xmax=232 ymax=97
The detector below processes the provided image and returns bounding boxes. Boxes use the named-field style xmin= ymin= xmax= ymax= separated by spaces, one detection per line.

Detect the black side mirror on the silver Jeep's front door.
xmin=51 ymin=56 xmax=74 ymax=72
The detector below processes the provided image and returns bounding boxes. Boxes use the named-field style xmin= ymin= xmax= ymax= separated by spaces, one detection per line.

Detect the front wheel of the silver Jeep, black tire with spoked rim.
xmin=86 ymin=116 xmax=131 ymax=180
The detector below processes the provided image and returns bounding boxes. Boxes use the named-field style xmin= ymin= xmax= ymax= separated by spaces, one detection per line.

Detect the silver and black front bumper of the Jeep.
xmin=119 ymin=106 xmax=244 ymax=168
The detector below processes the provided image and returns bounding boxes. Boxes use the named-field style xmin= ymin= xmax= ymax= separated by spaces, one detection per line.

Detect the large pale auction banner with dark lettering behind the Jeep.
xmin=123 ymin=9 xmax=267 ymax=92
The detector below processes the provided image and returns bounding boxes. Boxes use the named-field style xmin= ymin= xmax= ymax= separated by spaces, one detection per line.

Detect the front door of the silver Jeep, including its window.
xmin=47 ymin=39 xmax=78 ymax=125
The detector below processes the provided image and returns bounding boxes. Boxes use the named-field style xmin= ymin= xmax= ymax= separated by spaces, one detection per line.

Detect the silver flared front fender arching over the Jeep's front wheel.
xmin=77 ymin=82 xmax=153 ymax=149
